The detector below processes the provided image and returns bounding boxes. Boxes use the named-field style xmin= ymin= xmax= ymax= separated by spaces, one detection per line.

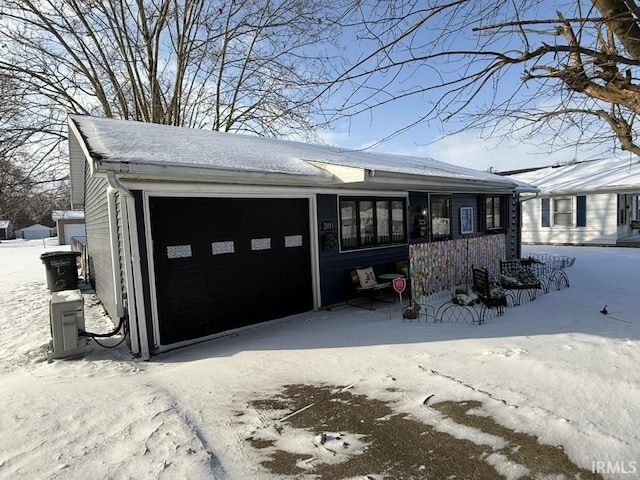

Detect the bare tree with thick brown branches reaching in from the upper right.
xmin=323 ymin=0 xmax=640 ymax=159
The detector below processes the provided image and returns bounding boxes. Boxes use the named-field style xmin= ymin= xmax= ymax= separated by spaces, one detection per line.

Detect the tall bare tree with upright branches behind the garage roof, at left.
xmin=0 ymin=0 xmax=349 ymax=186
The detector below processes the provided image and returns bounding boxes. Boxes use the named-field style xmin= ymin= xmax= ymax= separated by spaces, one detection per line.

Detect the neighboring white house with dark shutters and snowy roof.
xmin=505 ymin=158 xmax=640 ymax=245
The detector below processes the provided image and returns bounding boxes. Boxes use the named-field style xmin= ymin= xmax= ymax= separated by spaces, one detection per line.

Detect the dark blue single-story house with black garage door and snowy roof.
xmin=68 ymin=115 xmax=536 ymax=357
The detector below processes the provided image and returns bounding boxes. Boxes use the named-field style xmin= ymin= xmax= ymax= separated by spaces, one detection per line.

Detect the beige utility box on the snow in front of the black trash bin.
xmin=49 ymin=290 xmax=87 ymax=359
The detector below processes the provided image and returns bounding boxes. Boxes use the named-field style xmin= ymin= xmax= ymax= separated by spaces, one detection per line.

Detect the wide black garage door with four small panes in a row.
xmin=150 ymin=198 xmax=313 ymax=345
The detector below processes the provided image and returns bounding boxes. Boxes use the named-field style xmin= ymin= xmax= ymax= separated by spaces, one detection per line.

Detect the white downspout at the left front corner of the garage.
xmin=107 ymin=171 xmax=150 ymax=360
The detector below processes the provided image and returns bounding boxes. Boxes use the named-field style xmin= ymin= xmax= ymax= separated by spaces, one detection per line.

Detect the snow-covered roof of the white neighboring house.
xmin=507 ymin=158 xmax=640 ymax=194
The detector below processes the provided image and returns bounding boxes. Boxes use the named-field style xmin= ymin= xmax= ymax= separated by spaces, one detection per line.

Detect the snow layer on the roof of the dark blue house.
xmin=70 ymin=115 xmax=524 ymax=185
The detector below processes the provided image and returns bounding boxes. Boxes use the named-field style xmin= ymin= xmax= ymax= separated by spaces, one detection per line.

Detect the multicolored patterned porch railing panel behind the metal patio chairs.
xmin=409 ymin=234 xmax=506 ymax=302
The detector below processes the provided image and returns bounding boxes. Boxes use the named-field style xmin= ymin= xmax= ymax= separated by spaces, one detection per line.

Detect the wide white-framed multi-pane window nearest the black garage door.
xmin=340 ymin=197 xmax=406 ymax=250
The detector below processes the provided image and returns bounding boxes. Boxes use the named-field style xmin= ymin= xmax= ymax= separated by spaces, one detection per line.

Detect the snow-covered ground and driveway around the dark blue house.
xmin=0 ymin=240 xmax=640 ymax=480
